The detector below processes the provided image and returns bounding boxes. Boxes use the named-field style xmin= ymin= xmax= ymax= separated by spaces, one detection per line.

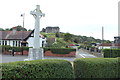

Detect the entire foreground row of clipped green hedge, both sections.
xmin=0 ymin=58 xmax=120 ymax=80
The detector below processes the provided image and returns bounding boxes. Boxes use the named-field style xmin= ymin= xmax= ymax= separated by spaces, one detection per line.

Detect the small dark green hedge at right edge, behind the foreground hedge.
xmin=103 ymin=49 xmax=120 ymax=58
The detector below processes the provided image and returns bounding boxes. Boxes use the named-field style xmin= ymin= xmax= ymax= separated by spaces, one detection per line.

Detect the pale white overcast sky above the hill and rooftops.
xmin=0 ymin=0 xmax=120 ymax=40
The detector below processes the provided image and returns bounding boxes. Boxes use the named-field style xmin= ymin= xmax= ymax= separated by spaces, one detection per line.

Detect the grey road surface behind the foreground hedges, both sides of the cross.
xmin=0 ymin=49 xmax=101 ymax=63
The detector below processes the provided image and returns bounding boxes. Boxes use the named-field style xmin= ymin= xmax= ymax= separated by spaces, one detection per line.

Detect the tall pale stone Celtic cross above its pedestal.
xmin=30 ymin=5 xmax=45 ymax=48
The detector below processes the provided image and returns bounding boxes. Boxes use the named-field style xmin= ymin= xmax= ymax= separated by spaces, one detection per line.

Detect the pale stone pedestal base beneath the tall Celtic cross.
xmin=24 ymin=48 xmax=44 ymax=61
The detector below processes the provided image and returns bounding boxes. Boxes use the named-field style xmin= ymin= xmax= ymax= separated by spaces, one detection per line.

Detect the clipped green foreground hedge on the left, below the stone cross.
xmin=0 ymin=59 xmax=74 ymax=79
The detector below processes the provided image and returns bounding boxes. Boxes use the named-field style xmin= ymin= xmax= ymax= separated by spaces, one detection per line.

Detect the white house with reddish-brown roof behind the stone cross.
xmin=0 ymin=29 xmax=46 ymax=47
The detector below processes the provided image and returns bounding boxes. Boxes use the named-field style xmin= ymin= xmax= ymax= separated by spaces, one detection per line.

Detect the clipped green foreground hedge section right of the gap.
xmin=74 ymin=58 xmax=120 ymax=79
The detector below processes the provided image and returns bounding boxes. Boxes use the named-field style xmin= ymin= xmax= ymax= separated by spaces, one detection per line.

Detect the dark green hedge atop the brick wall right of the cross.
xmin=44 ymin=48 xmax=76 ymax=54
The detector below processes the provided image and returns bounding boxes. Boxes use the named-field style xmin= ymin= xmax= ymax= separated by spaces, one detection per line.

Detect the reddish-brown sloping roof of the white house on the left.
xmin=0 ymin=31 xmax=32 ymax=40
